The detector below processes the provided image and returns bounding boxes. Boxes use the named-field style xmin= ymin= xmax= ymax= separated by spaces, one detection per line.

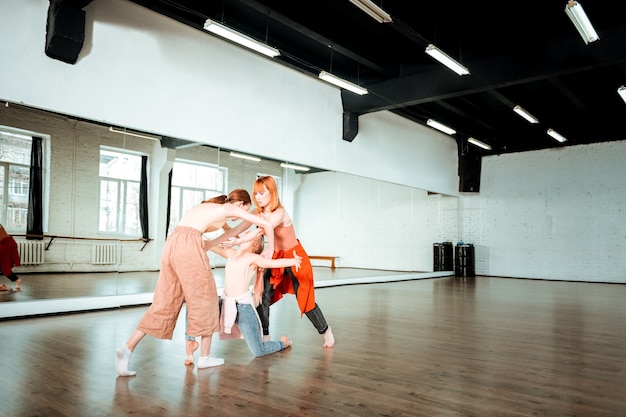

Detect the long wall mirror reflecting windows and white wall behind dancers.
xmin=0 ymin=105 xmax=458 ymax=318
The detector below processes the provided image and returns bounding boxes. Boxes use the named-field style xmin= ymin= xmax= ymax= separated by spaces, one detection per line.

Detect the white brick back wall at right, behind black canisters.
xmin=459 ymin=141 xmax=626 ymax=283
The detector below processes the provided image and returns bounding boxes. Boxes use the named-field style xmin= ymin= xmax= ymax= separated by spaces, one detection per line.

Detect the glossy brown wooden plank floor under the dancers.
xmin=0 ymin=276 xmax=626 ymax=417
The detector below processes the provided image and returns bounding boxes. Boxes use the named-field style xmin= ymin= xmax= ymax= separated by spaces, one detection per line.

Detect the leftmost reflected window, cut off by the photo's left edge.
xmin=0 ymin=127 xmax=32 ymax=229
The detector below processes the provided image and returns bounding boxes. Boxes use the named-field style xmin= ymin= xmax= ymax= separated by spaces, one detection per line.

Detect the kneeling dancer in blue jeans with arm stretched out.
xmin=185 ymin=232 xmax=302 ymax=365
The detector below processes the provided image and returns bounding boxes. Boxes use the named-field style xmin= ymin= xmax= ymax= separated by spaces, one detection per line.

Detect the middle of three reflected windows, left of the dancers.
xmin=98 ymin=147 xmax=141 ymax=236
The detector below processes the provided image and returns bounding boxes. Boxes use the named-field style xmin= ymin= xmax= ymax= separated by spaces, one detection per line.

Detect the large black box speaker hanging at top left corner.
xmin=46 ymin=0 xmax=85 ymax=64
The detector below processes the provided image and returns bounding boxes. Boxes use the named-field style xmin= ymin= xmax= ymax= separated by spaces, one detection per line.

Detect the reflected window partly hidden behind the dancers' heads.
xmin=168 ymin=160 xmax=228 ymax=231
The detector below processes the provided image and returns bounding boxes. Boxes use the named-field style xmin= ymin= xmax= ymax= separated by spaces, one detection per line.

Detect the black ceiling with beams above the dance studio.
xmin=127 ymin=0 xmax=626 ymax=155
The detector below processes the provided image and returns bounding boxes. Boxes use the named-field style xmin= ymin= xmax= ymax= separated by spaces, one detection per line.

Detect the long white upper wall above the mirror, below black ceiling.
xmin=0 ymin=0 xmax=458 ymax=195
